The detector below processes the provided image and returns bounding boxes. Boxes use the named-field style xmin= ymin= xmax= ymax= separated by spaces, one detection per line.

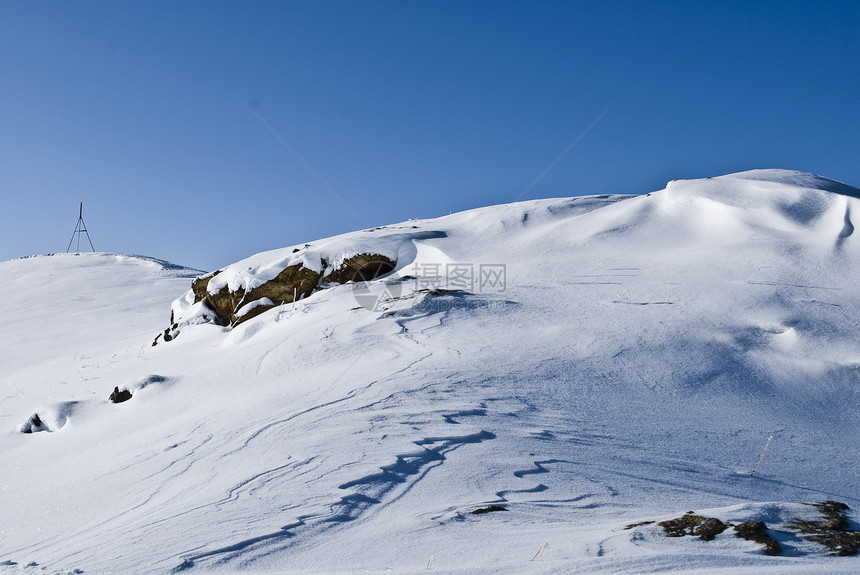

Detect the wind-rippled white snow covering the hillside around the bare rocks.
xmin=0 ymin=170 xmax=860 ymax=574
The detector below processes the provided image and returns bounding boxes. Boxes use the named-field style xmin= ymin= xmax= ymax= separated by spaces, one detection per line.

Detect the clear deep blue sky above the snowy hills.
xmin=0 ymin=0 xmax=860 ymax=270
